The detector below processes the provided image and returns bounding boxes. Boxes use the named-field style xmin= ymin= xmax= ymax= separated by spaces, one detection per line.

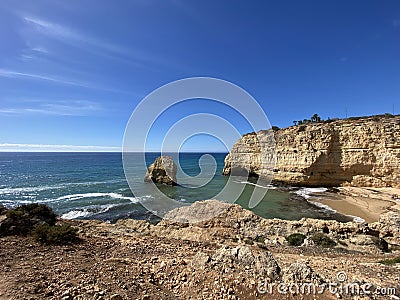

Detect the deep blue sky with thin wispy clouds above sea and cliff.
xmin=0 ymin=0 xmax=400 ymax=151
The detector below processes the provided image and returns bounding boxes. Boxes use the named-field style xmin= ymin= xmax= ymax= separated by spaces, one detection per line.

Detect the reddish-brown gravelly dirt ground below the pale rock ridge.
xmin=0 ymin=221 xmax=400 ymax=300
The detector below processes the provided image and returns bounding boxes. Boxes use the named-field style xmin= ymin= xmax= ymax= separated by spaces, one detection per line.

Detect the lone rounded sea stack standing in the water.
xmin=144 ymin=156 xmax=177 ymax=185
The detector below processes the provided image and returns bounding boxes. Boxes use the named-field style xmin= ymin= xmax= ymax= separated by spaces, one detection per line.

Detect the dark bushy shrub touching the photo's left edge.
xmin=0 ymin=203 xmax=57 ymax=236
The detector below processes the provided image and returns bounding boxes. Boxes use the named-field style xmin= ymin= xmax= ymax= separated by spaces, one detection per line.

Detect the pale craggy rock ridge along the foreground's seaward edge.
xmin=111 ymin=200 xmax=400 ymax=253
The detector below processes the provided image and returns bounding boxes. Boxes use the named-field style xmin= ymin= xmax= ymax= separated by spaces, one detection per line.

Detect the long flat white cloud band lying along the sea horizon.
xmin=0 ymin=143 xmax=121 ymax=152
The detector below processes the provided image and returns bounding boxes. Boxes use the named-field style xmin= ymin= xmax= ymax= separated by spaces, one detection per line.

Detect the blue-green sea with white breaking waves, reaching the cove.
xmin=0 ymin=152 xmax=351 ymax=222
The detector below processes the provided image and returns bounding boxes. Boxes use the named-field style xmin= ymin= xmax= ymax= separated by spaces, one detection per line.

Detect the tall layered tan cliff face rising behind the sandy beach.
xmin=223 ymin=116 xmax=400 ymax=187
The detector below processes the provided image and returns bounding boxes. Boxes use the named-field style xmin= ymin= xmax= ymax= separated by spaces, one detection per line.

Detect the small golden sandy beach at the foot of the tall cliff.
xmin=313 ymin=187 xmax=400 ymax=223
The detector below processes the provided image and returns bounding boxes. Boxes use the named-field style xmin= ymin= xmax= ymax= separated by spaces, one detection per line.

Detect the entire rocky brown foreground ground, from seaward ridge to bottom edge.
xmin=0 ymin=200 xmax=400 ymax=300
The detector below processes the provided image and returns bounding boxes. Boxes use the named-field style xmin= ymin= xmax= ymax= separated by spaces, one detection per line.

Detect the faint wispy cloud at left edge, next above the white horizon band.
xmin=0 ymin=100 xmax=102 ymax=116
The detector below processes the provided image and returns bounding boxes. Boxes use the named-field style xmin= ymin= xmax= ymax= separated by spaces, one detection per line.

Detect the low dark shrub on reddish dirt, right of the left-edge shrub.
xmin=31 ymin=224 xmax=79 ymax=245
